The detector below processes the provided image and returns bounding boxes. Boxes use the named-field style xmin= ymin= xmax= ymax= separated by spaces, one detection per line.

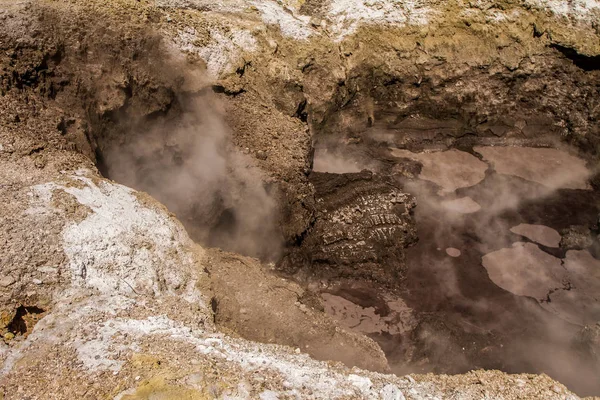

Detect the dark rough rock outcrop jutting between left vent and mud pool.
xmin=280 ymin=171 xmax=416 ymax=284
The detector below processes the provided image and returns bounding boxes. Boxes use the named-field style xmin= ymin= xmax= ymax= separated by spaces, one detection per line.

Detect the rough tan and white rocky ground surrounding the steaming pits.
xmin=0 ymin=0 xmax=600 ymax=399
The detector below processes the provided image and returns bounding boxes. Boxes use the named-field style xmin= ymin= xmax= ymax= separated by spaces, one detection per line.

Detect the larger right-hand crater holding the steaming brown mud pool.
xmin=292 ymin=84 xmax=600 ymax=394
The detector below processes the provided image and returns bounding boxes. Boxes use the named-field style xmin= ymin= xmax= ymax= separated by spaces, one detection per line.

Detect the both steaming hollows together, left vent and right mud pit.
xmin=83 ymin=66 xmax=600 ymax=393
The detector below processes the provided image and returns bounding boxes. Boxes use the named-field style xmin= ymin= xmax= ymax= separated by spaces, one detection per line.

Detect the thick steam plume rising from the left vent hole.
xmin=104 ymin=95 xmax=281 ymax=258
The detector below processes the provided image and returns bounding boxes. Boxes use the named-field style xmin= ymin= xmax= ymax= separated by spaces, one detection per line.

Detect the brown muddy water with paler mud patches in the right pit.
xmin=314 ymin=147 xmax=600 ymax=395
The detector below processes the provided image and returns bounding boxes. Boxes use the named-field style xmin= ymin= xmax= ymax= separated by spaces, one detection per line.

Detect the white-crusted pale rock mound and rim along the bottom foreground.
xmin=0 ymin=162 xmax=580 ymax=399
